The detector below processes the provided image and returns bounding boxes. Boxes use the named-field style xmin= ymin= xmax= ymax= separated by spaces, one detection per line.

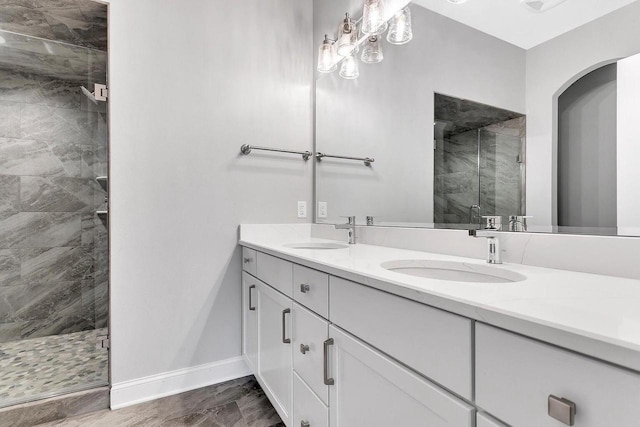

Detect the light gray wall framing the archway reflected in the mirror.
xmin=526 ymin=2 xmax=640 ymax=231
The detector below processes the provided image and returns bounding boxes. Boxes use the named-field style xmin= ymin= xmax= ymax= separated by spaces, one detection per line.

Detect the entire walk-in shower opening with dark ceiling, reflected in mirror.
xmin=434 ymin=94 xmax=526 ymax=228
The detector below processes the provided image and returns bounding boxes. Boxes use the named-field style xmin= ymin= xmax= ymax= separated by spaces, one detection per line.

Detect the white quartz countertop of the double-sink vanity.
xmin=239 ymin=225 xmax=640 ymax=372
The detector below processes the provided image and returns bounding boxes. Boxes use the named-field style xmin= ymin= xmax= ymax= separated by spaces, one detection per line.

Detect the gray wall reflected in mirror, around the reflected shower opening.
xmin=314 ymin=0 xmax=525 ymax=224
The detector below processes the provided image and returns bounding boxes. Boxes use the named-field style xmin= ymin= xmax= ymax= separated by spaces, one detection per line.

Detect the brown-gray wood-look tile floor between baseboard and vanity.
xmin=39 ymin=376 xmax=284 ymax=427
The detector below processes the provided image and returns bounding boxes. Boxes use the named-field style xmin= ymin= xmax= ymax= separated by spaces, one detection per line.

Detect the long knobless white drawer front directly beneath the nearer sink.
xmin=329 ymin=276 xmax=473 ymax=400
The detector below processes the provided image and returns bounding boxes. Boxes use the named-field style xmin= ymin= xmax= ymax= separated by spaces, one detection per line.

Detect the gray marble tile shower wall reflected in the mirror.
xmin=434 ymin=117 xmax=526 ymax=224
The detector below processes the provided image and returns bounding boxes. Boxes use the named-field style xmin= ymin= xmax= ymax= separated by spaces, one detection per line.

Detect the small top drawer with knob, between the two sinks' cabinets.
xmin=293 ymin=265 xmax=329 ymax=318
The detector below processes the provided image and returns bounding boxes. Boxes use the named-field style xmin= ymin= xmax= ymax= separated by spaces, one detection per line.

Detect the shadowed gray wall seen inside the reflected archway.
xmin=558 ymin=64 xmax=617 ymax=227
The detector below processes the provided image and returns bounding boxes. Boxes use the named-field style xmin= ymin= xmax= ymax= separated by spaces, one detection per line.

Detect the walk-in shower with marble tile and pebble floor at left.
xmin=0 ymin=0 xmax=109 ymax=407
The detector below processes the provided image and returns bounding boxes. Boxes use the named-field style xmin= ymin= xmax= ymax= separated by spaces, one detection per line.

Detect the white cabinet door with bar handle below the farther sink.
xmin=258 ymin=282 xmax=293 ymax=425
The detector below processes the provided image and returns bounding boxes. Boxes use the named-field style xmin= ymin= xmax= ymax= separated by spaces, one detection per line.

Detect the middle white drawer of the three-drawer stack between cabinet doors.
xmin=293 ymin=303 xmax=329 ymax=404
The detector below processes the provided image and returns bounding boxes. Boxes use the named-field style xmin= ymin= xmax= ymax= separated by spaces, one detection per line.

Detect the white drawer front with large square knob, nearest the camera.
xmin=476 ymin=323 xmax=640 ymax=427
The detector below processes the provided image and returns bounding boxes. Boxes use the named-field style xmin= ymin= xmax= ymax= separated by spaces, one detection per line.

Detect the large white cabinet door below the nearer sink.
xmin=326 ymin=326 xmax=475 ymax=427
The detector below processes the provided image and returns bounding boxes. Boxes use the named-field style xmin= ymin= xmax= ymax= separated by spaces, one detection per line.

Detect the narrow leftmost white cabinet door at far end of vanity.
xmin=242 ymin=272 xmax=258 ymax=374
